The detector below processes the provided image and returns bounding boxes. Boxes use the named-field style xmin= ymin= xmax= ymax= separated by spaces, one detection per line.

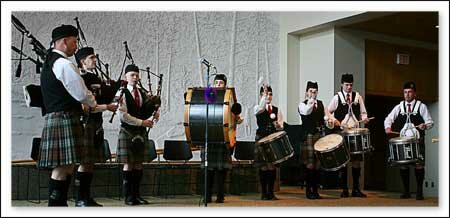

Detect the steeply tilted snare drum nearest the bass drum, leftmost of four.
xmin=255 ymin=131 xmax=294 ymax=164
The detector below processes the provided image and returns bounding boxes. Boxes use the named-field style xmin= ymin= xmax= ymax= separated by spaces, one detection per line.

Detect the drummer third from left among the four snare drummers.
xmin=328 ymin=74 xmax=369 ymax=198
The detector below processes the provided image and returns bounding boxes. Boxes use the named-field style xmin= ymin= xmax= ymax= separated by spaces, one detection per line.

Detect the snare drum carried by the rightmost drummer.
xmin=388 ymin=137 xmax=424 ymax=165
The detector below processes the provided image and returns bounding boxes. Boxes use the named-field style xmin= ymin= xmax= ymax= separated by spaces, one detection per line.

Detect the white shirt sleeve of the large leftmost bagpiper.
xmin=52 ymin=49 xmax=97 ymax=107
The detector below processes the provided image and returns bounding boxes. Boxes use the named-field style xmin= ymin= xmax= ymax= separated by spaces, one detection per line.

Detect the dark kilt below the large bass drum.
xmin=200 ymin=143 xmax=233 ymax=170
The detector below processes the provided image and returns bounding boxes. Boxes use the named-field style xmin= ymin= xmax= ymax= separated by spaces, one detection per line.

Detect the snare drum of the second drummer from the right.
xmin=342 ymin=128 xmax=374 ymax=154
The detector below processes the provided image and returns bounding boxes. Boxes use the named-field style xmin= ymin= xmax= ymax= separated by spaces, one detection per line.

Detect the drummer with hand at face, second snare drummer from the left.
xmin=298 ymin=81 xmax=339 ymax=199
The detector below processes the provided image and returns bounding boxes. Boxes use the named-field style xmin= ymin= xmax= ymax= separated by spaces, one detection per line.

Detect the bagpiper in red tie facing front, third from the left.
xmin=116 ymin=64 xmax=161 ymax=205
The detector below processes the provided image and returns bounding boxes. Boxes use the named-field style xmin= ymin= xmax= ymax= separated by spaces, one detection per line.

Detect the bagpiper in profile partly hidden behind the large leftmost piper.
xmin=75 ymin=47 xmax=117 ymax=207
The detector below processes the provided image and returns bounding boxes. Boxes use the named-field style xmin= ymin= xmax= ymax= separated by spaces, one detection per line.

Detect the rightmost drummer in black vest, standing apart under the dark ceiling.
xmin=384 ymin=82 xmax=433 ymax=200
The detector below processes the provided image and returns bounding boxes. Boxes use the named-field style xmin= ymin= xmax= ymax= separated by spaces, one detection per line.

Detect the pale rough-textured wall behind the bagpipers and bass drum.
xmin=11 ymin=12 xmax=279 ymax=160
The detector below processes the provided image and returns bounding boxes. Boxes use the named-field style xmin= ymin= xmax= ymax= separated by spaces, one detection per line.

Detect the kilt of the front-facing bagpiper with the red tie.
xmin=116 ymin=127 xmax=153 ymax=163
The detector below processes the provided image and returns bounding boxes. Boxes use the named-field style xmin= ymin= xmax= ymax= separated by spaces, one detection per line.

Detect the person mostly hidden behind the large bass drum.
xmin=201 ymin=74 xmax=243 ymax=203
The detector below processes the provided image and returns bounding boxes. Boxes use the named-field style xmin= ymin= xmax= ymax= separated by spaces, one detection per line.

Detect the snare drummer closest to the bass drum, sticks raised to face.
xmin=254 ymin=85 xmax=283 ymax=200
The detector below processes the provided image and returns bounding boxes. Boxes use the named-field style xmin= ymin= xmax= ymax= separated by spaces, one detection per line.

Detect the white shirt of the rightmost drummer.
xmin=384 ymin=99 xmax=434 ymax=129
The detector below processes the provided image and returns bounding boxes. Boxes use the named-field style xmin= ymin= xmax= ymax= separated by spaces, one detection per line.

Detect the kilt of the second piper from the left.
xmin=81 ymin=118 xmax=107 ymax=164
